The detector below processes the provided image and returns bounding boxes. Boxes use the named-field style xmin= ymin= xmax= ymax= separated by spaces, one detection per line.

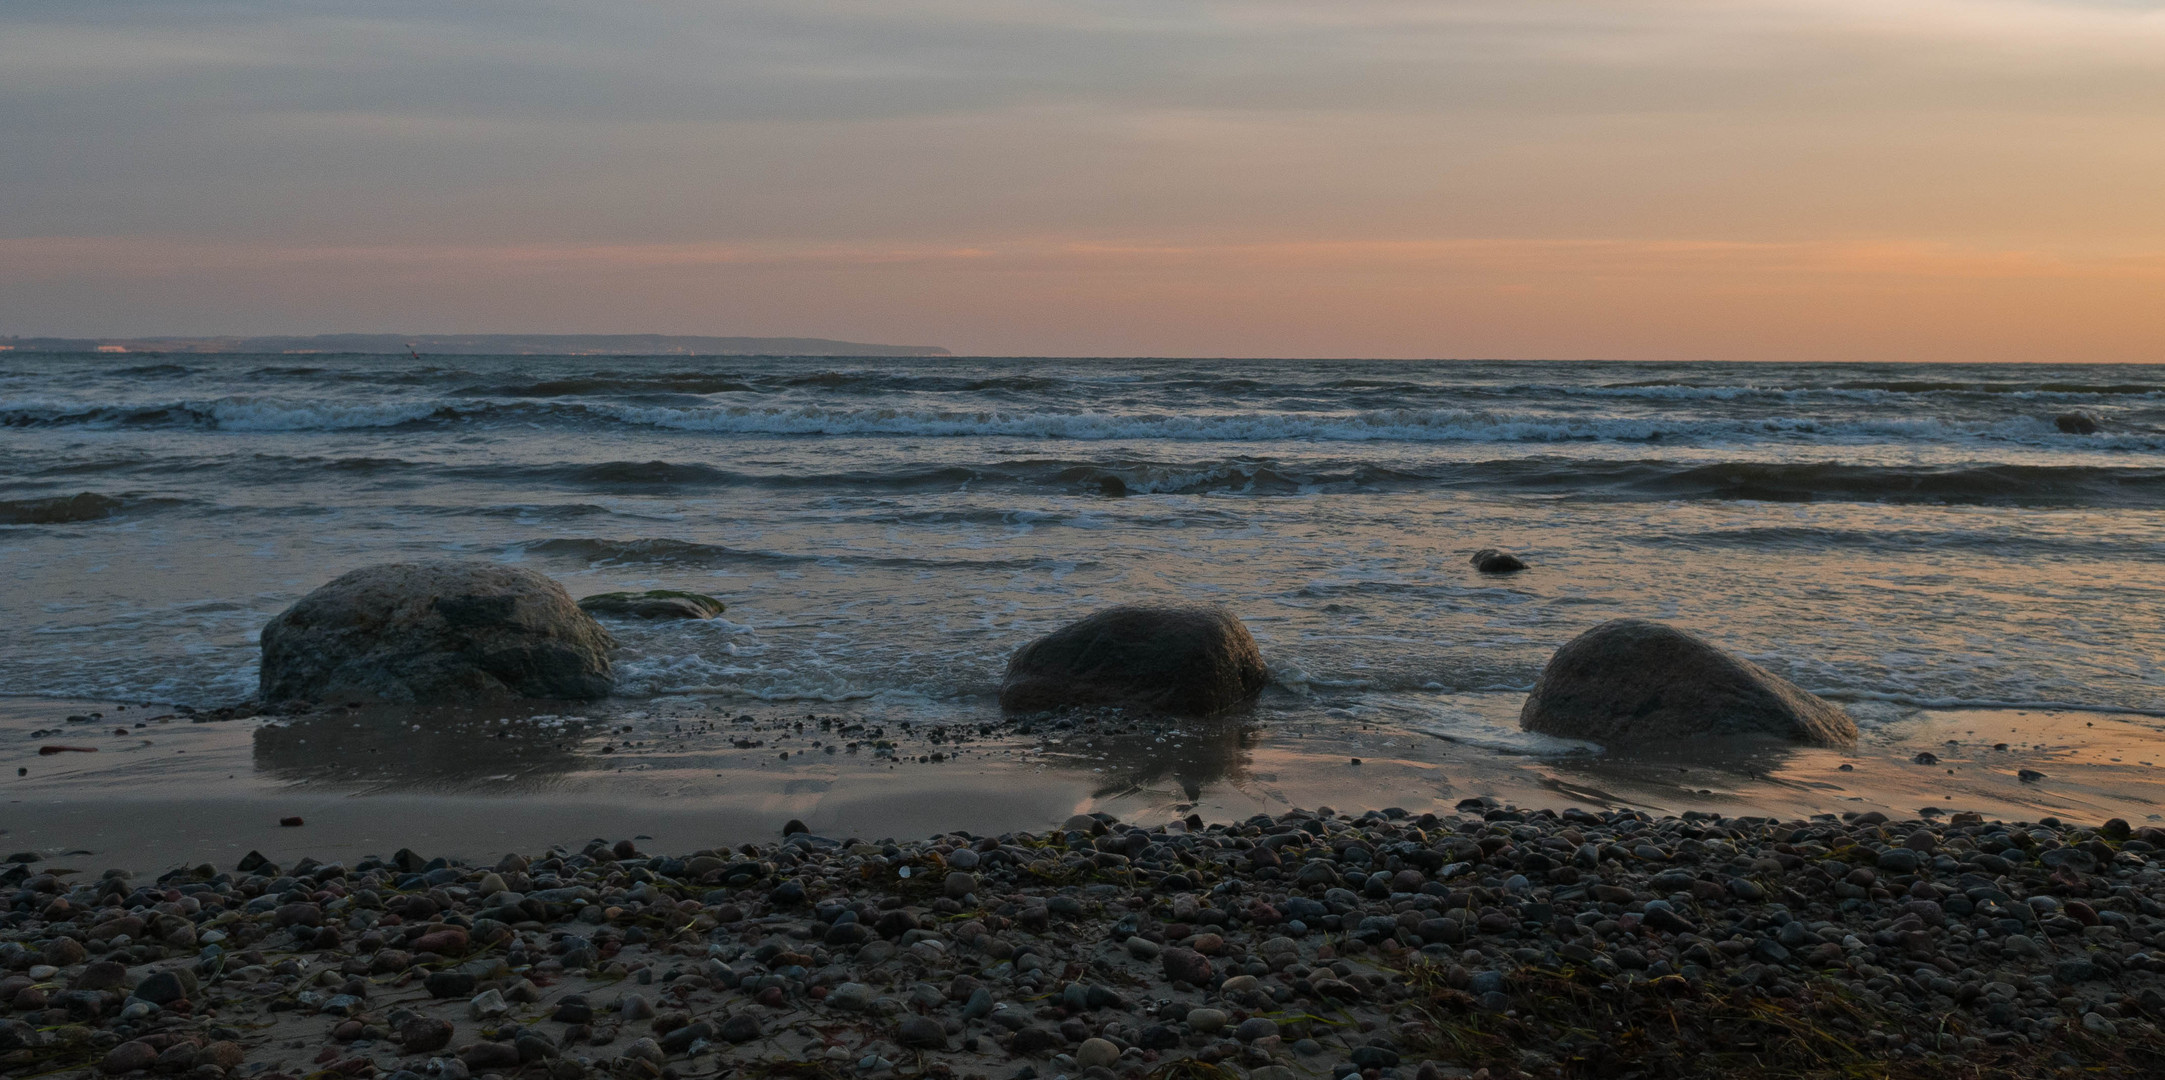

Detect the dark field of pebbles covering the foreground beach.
xmin=0 ymin=799 xmax=2165 ymax=1080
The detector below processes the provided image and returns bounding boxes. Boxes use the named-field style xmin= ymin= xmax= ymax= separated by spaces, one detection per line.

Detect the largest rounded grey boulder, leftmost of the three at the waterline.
xmin=260 ymin=563 xmax=615 ymax=703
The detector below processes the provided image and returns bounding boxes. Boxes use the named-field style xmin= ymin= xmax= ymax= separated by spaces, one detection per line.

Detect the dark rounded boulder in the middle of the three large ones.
xmin=1000 ymin=606 xmax=1269 ymax=716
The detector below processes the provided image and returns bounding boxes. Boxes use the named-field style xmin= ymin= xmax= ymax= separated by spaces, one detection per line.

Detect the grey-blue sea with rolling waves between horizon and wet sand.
xmin=0 ymin=353 xmax=2165 ymax=751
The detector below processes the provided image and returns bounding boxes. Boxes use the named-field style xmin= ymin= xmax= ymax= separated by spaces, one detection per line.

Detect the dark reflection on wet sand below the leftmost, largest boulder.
xmin=255 ymin=708 xmax=602 ymax=792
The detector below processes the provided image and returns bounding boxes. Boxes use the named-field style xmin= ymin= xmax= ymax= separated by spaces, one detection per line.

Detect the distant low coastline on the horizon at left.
xmin=0 ymin=333 xmax=953 ymax=357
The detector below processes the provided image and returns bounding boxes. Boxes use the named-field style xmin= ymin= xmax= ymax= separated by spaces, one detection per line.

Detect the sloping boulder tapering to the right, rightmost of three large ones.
xmin=1518 ymin=619 xmax=1858 ymax=749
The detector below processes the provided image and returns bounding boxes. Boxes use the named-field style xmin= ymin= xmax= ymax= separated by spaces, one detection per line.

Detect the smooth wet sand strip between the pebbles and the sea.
xmin=0 ymin=699 xmax=2165 ymax=872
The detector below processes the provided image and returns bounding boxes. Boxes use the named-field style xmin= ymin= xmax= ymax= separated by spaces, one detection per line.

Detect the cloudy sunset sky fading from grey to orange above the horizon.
xmin=0 ymin=0 xmax=2165 ymax=361
